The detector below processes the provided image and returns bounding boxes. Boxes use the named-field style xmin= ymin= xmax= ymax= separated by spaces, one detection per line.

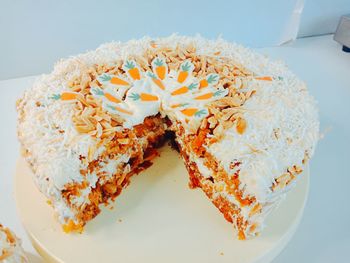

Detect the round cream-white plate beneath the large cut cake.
xmin=15 ymin=146 xmax=309 ymax=263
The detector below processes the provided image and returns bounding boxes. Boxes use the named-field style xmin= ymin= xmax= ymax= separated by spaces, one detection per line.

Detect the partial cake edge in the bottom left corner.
xmin=0 ymin=224 xmax=28 ymax=263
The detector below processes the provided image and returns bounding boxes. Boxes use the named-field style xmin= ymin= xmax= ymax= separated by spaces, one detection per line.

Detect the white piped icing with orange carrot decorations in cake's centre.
xmin=53 ymin=57 xmax=228 ymax=127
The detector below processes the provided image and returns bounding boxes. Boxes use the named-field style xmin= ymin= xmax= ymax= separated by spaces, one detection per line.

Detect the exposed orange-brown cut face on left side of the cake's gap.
xmin=62 ymin=115 xmax=166 ymax=232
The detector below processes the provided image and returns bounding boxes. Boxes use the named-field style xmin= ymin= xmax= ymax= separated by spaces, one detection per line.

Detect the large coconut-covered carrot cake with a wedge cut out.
xmin=17 ymin=35 xmax=319 ymax=239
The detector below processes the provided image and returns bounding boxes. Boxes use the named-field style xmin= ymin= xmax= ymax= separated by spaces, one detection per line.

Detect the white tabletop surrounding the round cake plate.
xmin=0 ymin=35 xmax=350 ymax=262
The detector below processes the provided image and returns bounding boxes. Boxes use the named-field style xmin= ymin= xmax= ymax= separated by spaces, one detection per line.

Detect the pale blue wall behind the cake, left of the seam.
xmin=0 ymin=0 xmax=350 ymax=79
